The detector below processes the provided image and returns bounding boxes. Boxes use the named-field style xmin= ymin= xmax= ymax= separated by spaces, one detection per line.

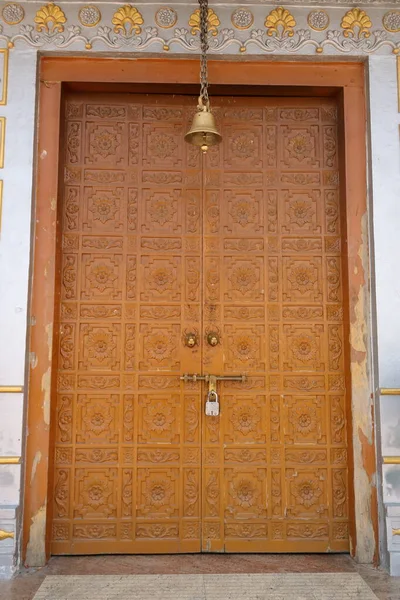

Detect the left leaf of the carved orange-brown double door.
xmin=51 ymin=95 xmax=202 ymax=554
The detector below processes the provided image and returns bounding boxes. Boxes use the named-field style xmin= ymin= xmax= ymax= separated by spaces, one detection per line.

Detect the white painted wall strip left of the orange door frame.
xmin=0 ymin=49 xmax=36 ymax=577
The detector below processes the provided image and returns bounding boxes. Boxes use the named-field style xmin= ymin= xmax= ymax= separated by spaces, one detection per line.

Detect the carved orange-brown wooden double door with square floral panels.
xmin=50 ymin=94 xmax=349 ymax=554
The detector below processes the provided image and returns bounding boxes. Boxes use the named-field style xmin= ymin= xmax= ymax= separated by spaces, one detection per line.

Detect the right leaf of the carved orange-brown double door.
xmin=202 ymin=98 xmax=349 ymax=552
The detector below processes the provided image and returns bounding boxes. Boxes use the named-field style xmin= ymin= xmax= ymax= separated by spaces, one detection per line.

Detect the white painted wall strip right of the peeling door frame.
xmin=369 ymin=56 xmax=400 ymax=575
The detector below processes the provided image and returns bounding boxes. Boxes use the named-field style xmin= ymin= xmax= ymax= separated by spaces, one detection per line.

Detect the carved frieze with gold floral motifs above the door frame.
xmin=0 ymin=2 xmax=400 ymax=55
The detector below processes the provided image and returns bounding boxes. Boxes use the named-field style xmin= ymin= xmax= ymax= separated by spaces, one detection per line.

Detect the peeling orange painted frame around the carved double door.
xmin=23 ymin=57 xmax=378 ymax=566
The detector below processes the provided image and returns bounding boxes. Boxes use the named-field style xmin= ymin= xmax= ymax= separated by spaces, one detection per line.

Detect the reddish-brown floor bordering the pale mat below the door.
xmin=0 ymin=554 xmax=400 ymax=600
